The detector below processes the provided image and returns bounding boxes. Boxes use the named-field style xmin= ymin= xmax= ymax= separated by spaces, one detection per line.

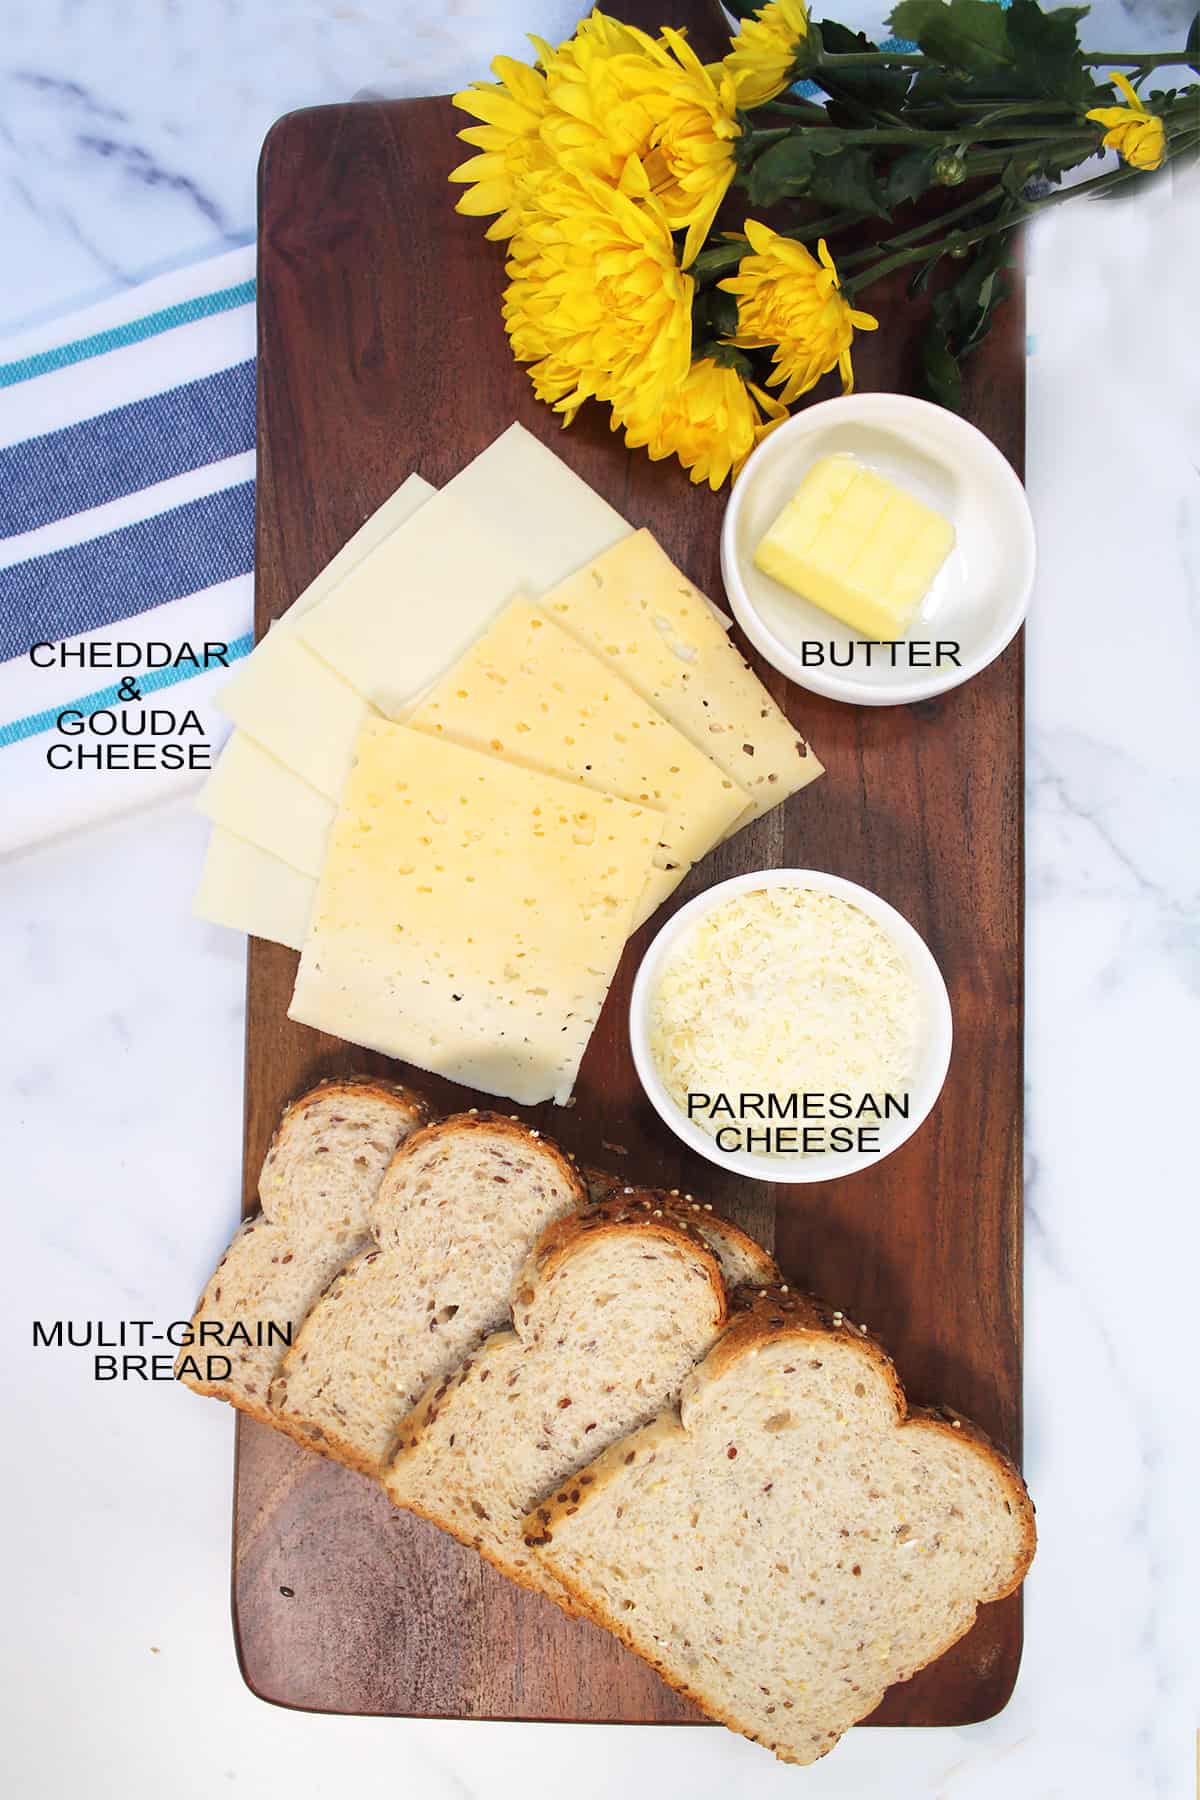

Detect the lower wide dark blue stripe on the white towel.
xmin=0 ymin=481 xmax=254 ymax=662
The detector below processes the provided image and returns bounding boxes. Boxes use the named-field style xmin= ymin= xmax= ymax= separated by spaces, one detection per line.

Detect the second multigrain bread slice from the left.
xmin=270 ymin=1112 xmax=587 ymax=1476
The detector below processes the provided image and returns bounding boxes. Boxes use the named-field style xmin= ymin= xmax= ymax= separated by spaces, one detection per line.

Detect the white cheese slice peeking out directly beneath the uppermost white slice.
xmin=216 ymin=475 xmax=435 ymax=799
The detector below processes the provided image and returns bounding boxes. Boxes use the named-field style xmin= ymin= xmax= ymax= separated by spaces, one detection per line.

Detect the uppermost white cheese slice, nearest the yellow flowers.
xmin=299 ymin=425 xmax=630 ymax=718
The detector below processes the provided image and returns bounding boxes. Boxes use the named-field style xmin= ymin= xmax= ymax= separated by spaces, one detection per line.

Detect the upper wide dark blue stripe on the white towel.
xmin=0 ymin=358 xmax=254 ymax=538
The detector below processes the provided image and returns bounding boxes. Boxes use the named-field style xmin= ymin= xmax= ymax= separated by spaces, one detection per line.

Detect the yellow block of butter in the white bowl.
xmin=754 ymin=455 xmax=954 ymax=641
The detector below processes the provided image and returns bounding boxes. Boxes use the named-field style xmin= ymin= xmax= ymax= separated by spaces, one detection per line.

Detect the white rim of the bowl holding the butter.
xmin=721 ymin=392 xmax=1038 ymax=706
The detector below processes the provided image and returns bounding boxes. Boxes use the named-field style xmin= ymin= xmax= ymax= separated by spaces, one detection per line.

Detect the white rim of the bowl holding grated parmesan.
xmin=630 ymin=869 xmax=954 ymax=1183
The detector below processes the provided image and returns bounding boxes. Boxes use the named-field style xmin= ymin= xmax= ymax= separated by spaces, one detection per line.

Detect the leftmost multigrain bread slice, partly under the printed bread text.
xmin=180 ymin=1076 xmax=430 ymax=1424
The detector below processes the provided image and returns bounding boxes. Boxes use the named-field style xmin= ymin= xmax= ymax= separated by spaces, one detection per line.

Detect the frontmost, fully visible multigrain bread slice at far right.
xmin=525 ymin=1291 xmax=1034 ymax=1762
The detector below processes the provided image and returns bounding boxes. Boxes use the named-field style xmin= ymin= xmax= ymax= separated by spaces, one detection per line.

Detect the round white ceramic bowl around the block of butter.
xmin=721 ymin=394 xmax=1034 ymax=706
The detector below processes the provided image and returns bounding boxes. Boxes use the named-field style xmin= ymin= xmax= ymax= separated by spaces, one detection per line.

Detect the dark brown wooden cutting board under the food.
xmin=234 ymin=0 xmax=1024 ymax=1724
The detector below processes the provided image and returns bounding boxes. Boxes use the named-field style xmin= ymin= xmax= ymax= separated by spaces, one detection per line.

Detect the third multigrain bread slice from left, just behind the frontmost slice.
xmin=383 ymin=1188 xmax=777 ymax=1600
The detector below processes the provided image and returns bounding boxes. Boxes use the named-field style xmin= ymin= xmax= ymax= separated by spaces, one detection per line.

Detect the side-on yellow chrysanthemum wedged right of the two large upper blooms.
xmin=621 ymin=27 xmax=741 ymax=268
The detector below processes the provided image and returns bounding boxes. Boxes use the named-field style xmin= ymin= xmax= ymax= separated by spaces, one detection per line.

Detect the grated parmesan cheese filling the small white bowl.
xmin=649 ymin=887 xmax=921 ymax=1154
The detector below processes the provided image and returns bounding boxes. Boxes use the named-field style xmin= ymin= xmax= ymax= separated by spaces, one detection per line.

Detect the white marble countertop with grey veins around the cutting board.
xmin=0 ymin=0 xmax=1200 ymax=1800
